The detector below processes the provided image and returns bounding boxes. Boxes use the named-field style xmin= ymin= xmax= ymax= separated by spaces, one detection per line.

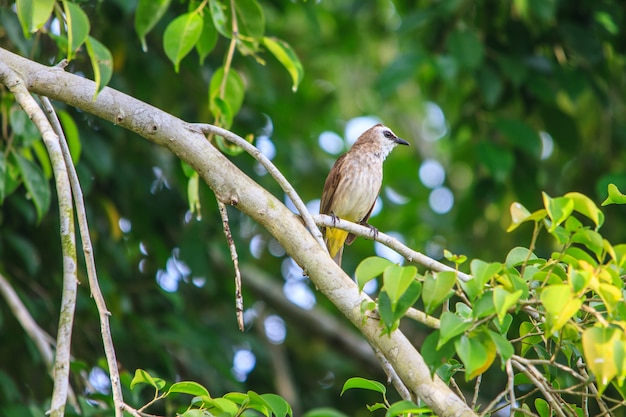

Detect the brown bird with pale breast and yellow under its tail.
xmin=320 ymin=124 xmax=409 ymax=266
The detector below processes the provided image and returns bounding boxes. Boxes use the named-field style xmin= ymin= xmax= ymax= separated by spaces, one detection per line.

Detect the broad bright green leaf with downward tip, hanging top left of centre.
xmin=163 ymin=12 xmax=204 ymax=73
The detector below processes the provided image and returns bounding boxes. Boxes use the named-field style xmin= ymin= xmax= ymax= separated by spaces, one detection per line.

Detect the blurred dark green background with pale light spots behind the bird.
xmin=0 ymin=0 xmax=626 ymax=416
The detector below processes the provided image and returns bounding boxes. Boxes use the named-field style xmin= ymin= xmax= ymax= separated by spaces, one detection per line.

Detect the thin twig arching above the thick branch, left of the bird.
xmin=189 ymin=123 xmax=326 ymax=248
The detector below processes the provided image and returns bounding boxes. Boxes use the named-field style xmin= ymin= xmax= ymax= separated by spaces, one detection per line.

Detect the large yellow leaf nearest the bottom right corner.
xmin=582 ymin=327 xmax=623 ymax=395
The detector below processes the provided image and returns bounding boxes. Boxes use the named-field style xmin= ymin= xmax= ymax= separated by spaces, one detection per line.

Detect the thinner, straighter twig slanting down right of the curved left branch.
xmin=39 ymin=96 xmax=124 ymax=417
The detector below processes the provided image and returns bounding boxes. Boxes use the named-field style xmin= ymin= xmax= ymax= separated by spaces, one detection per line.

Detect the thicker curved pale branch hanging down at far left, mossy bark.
xmin=0 ymin=58 xmax=78 ymax=417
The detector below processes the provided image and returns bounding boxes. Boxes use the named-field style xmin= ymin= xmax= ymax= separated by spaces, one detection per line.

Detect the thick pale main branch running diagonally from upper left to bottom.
xmin=0 ymin=49 xmax=476 ymax=417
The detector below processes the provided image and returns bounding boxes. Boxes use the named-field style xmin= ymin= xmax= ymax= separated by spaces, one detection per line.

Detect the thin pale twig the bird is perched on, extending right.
xmin=313 ymin=214 xmax=471 ymax=281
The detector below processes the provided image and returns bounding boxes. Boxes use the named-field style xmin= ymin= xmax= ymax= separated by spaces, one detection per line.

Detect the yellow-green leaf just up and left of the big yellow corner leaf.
xmin=539 ymin=284 xmax=583 ymax=333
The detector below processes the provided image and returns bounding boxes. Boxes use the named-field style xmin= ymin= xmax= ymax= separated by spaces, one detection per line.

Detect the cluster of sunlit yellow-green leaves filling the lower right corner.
xmin=357 ymin=186 xmax=626 ymax=415
